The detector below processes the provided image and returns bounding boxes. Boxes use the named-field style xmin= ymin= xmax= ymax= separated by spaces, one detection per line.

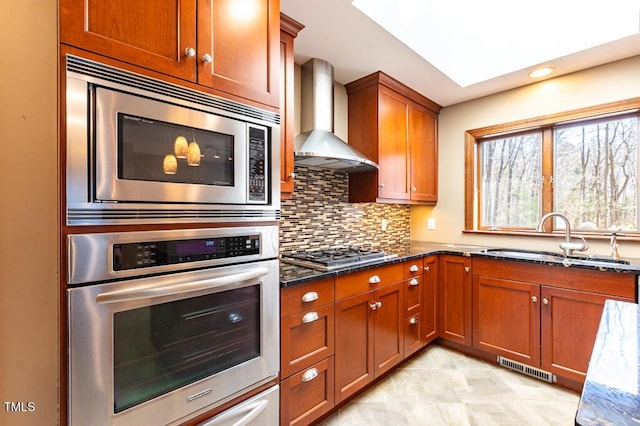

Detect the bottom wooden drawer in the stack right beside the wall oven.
xmin=280 ymin=357 xmax=334 ymax=425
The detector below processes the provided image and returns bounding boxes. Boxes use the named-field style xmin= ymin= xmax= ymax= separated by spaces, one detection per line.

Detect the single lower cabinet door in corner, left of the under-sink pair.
xmin=438 ymin=255 xmax=471 ymax=346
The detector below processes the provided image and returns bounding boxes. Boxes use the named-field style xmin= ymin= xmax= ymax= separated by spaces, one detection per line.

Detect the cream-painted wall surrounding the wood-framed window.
xmin=411 ymin=56 xmax=640 ymax=258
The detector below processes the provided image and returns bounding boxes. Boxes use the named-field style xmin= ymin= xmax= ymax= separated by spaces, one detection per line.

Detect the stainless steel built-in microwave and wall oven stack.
xmin=65 ymin=56 xmax=280 ymax=425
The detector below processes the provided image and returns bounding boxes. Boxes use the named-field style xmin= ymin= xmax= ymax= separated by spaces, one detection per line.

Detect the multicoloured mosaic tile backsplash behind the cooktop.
xmin=280 ymin=166 xmax=410 ymax=252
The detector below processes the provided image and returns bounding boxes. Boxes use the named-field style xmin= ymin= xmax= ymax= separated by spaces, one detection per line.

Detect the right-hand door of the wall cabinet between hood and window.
xmin=409 ymin=103 xmax=438 ymax=204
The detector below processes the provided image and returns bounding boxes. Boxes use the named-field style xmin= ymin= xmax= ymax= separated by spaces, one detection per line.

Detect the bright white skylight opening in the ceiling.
xmin=352 ymin=0 xmax=640 ymax=87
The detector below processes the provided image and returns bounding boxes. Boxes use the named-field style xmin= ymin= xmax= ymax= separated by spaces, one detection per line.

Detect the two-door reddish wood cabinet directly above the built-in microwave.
xmin=60 ymin=0 xmax=280 ymax=108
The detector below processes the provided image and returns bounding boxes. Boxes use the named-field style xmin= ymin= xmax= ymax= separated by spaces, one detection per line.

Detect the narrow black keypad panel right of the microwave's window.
xmin=248 ymin=126 xmax=268 ymax=204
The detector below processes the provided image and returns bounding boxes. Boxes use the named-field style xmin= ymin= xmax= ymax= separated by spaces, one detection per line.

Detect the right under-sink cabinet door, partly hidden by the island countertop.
xmin=541 ymin=287 xmax=633 ymax=383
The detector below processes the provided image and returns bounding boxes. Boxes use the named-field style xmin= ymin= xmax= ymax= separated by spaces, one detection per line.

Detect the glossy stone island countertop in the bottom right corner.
xmin=576 ymin=300 xmax=640 ymax=426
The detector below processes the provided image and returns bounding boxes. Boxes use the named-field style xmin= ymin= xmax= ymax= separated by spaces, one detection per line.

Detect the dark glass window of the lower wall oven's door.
xmin=113 ymin=285 xmax=261 ymax=413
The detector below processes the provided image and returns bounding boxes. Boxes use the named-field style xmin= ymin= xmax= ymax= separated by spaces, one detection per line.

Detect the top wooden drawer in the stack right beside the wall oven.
xmin=280 ymin=278 xmax=334 ymax=317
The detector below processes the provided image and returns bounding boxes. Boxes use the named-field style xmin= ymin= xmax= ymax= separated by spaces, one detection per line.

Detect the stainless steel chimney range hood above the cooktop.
xmin=294 ymin=58 xmax=378 ymax=173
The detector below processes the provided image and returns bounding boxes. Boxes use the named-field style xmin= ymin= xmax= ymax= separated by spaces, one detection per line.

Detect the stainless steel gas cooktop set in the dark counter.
xmin=282 ymin=247 xmax=385 ymax=271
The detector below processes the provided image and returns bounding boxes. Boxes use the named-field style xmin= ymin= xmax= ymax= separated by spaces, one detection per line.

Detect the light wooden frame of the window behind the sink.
xmin=463 ymin=97 xmax=640 ymax=241
